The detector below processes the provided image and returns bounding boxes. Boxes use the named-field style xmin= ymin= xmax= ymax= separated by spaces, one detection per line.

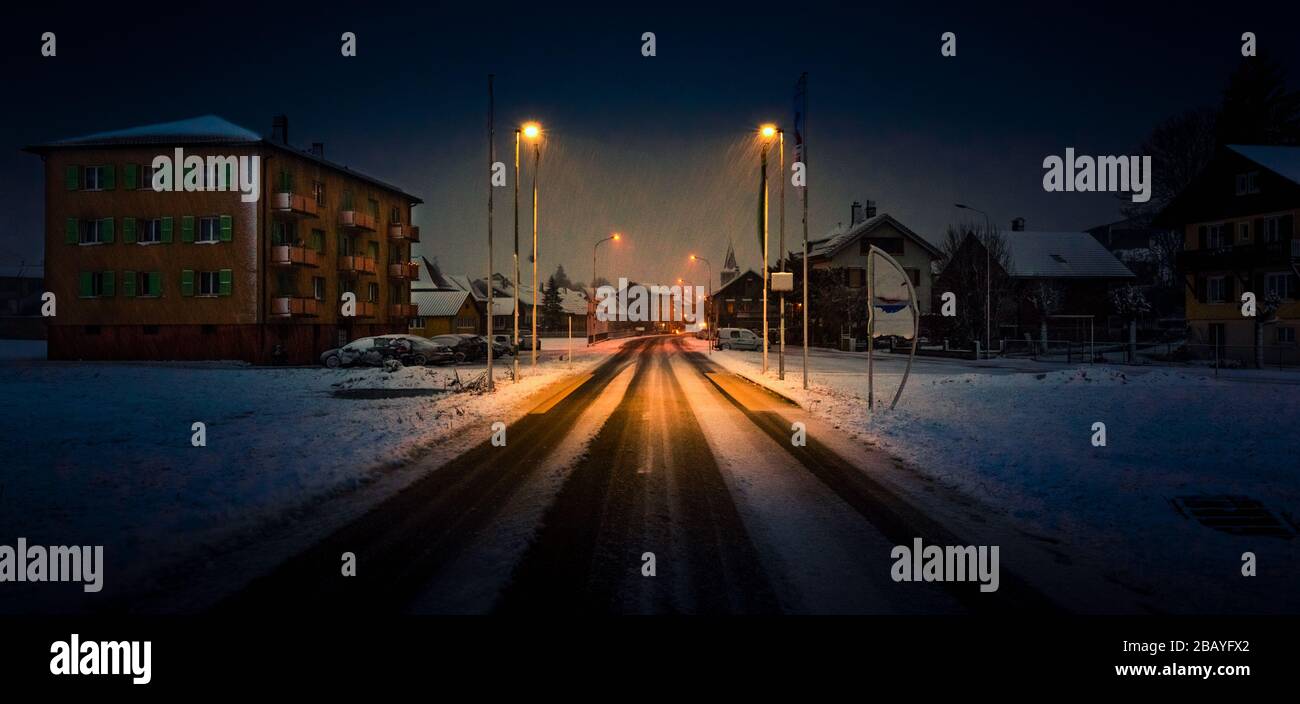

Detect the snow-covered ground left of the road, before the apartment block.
xmin=0 ymin=340 xmax=623 ymax=610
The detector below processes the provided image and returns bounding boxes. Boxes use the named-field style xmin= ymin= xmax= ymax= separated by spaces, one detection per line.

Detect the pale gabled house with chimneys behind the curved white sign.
xmin=792 ymin=200 xmax=944 ymax=316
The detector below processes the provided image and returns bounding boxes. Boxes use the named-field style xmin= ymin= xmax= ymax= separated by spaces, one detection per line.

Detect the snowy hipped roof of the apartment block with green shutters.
xmin=26 ymin=114 xmax=424 ymax=203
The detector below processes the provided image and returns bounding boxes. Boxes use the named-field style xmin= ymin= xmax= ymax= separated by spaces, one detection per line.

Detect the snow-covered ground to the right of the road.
xmin=690 ymin=340 xmax=1300 ymax=612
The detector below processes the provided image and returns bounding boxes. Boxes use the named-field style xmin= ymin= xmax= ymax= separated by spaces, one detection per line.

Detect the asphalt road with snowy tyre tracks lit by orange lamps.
xmin=226 ymin=336 xmax=1054 ymax=614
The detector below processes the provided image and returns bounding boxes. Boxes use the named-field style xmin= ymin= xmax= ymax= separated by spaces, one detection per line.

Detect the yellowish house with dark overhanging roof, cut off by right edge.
xmin=1157 ymin=144 xmax=1300 ymax=365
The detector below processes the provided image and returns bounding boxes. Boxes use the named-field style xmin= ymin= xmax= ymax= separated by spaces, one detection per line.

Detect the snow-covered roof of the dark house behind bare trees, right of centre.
xmin=1001 ymin=230 xmax=1135 ymax=279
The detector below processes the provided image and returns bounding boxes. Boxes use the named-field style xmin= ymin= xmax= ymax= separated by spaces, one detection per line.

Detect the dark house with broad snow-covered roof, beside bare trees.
xmin=935 ymin=220 xmax=1136 ymax=347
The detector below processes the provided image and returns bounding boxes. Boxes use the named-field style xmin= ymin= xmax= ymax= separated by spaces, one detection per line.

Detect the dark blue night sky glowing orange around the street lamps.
xmin=0 ymin=3 xmax=1300 ymax=288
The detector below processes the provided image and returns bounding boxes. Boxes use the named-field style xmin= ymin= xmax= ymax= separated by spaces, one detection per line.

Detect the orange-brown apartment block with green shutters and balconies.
xmin=26 ymin=116 xmax=421 ymax=364
